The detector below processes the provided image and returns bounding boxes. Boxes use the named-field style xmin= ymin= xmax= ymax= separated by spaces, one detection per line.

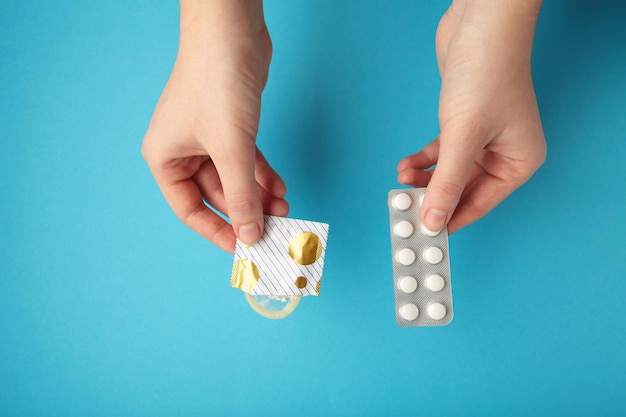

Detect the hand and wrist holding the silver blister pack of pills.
xmin=398 ymin=0 xmax=546 ymax=233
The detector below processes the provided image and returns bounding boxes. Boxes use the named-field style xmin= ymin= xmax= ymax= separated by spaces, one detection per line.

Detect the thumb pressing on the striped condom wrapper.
xmin=214 ymin=138 xmax=263 ymax=245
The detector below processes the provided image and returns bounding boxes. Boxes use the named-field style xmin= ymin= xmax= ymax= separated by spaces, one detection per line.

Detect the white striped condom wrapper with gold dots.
xmin=230 ymin=216 xmax=328 ymax=297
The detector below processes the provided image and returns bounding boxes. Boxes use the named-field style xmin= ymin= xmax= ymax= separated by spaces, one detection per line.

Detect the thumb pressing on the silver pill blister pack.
xmin=421 ymin=130 xmax=476 ymax=232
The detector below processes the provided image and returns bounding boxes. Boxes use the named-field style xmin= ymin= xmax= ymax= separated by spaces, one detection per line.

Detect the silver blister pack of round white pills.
xmin=387 ymin=188 xmax=453 ymax=327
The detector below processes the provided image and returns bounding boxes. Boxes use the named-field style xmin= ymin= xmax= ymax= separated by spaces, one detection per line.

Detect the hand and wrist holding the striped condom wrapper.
xmin=142 ymin=0 xmax=289 ymax=252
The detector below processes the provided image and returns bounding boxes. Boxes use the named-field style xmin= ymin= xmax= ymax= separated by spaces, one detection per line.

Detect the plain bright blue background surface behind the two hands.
xmin=0 ymin=0 xmax=626 ymax=416
